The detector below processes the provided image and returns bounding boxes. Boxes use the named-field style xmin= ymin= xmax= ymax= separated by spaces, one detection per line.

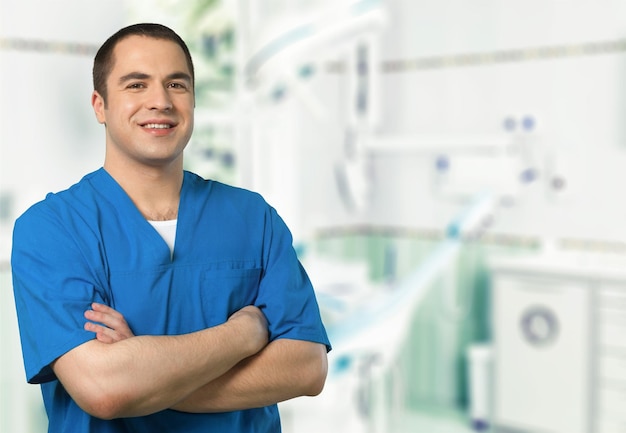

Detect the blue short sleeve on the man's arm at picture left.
xmin=11 ymin=202 xmax=106 ymax=383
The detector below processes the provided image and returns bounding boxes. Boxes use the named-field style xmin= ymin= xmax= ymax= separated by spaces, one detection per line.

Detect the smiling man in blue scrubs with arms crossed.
xmin=12 ymin=24 xmax=330 ymax=433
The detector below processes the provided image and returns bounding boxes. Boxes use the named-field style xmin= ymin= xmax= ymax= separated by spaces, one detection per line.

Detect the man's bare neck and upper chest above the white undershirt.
xmin=104 ymin=160 xmax=183 ymax=221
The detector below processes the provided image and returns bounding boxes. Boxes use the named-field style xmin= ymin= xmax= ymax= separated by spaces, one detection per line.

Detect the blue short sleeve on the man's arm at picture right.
xmin=257 ymin=207 xmax=331 ymax=351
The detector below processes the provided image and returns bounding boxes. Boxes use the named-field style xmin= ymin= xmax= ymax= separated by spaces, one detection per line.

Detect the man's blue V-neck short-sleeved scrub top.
xmin=12 ymin=169 xmax=330 ymax=432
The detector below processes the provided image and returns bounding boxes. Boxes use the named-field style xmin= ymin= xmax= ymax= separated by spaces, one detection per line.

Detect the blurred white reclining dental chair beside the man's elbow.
xmin=281 ymin=192 xmax=492 ymax=433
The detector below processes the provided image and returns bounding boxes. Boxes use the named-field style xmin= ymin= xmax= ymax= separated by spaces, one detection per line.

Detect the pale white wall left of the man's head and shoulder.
xmin=0 ymin=0 xmax=130 ymax=263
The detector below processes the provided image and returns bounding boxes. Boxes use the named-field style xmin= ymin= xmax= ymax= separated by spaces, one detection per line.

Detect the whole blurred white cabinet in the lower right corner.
xmin=492 ymin=257 xmax=626 ymax=433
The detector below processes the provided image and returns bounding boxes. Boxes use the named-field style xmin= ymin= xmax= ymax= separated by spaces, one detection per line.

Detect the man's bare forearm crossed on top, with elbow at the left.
xmin=53 ymin=306 xmax=262 ymax=418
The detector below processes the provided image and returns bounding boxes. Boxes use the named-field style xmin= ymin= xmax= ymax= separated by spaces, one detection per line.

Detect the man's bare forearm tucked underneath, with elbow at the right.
xmin=172 ymin=339 xmax=327 ymax=413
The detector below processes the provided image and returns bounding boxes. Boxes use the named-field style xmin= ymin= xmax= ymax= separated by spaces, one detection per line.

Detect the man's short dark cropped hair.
xmin=93 ymin=23 xmax=195 ymax=104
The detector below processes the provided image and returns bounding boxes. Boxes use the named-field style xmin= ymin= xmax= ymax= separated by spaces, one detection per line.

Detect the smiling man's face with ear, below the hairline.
xmin=92 ymin=36 xmax=194 ymax=168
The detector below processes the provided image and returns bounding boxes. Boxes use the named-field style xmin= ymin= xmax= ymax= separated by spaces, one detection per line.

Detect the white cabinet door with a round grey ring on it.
xmin=493 ymin=274 xmax=590 ymax=433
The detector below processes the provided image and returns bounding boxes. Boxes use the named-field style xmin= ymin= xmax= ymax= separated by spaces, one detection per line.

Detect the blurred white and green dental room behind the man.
xmin=0 ymin=0 xmax=626 ymax=433
